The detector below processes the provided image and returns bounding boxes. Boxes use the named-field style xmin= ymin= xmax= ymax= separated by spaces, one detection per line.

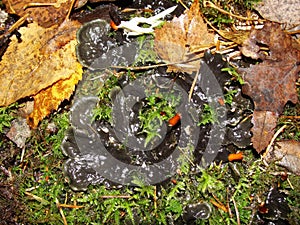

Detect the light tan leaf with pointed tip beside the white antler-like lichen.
xmin=155 ymin=1 xmax=214 ymax=73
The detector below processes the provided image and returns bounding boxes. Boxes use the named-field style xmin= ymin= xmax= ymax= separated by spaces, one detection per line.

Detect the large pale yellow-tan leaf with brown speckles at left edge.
xmin=0 ymin=21 xmax=80 ymax=106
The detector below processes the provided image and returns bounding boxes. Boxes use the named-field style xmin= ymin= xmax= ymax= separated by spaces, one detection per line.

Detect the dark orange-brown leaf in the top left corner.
xmin=2 ymin=0 xmax=72 ymax=28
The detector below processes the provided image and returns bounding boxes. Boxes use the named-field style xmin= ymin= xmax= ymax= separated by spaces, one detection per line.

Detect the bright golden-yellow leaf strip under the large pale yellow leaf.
xmin=27 ymin=66 xmax=82 ymax=128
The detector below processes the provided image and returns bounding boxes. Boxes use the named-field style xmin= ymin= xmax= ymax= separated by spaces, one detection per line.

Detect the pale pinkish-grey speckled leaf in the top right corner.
xmin=255 ymin=0 xmax=300 ymax=28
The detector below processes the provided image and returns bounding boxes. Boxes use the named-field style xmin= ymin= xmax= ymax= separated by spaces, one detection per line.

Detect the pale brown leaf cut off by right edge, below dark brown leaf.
xmin=265 ymin=140 xmax=300 ymax=175
